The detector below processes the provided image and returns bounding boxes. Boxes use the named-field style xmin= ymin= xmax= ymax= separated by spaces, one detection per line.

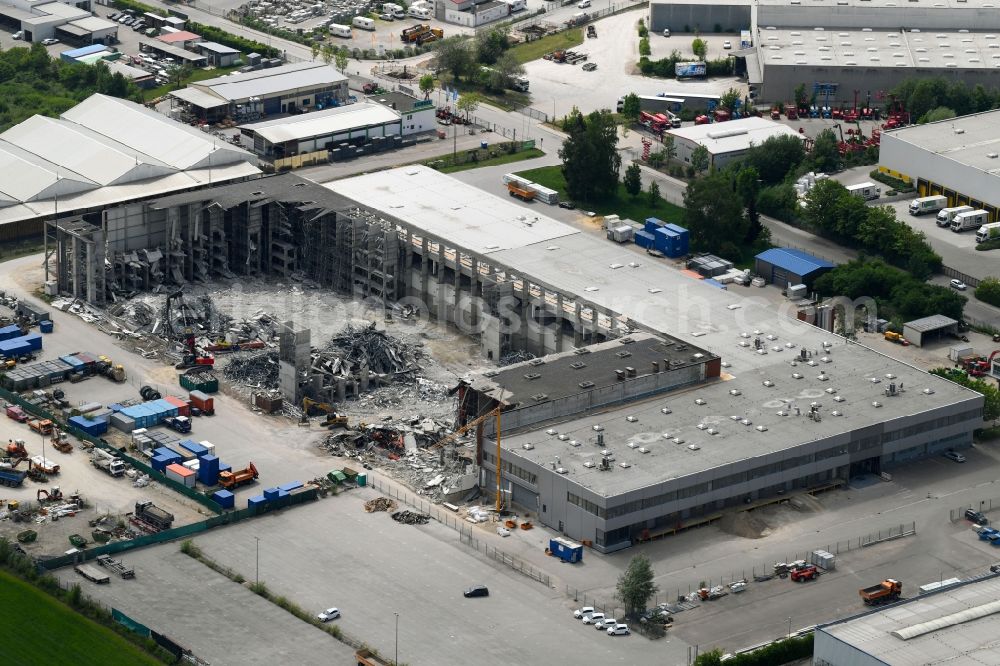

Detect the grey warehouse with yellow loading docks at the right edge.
xmin=879 ymin=109 xmax=1000 ymax=222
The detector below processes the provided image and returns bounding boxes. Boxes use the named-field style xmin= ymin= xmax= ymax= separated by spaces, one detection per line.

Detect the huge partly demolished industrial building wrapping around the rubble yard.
xmin=48 ymin=166 xmax=983 ymax=551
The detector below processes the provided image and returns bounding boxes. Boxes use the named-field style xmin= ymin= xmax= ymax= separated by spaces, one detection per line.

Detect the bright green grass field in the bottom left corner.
xmin=0 ymin=571 xmax=161 ymax=666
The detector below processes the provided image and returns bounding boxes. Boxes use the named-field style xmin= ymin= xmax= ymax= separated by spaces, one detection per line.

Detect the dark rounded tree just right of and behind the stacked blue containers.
xmin=684 ymin=171 xmax=749 ymax=253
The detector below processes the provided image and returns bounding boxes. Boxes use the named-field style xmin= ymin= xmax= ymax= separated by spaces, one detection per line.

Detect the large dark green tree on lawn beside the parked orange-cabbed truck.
xmin=559 ymin=108 xmax=622 ymax=202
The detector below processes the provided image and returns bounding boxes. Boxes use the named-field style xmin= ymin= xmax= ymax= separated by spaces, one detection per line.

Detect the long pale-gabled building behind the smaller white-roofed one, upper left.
xmin=170 ymin=62 xmax=348 ymax=123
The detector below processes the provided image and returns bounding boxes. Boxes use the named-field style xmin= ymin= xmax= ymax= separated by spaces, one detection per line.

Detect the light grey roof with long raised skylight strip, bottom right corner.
xmin=816 ymin=576 xmax=1000 ymax=666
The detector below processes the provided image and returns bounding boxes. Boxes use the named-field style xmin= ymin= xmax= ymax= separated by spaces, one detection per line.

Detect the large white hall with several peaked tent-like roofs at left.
xmin=0 ymin=94 xmax=260 ymax=240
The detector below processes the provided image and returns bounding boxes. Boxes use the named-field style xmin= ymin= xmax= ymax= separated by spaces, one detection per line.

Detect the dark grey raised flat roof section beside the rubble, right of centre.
xmin=468 ymin=333 xmax=714 ymax=406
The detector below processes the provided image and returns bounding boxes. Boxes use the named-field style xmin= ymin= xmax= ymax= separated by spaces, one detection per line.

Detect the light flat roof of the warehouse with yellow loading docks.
xmin=884 ymin=111 xmax=1000 ymax=174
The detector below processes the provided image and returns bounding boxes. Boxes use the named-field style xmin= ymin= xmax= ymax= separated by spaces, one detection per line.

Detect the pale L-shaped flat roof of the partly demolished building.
xmin=325 ymin=166 xmax=982 ymax=495
